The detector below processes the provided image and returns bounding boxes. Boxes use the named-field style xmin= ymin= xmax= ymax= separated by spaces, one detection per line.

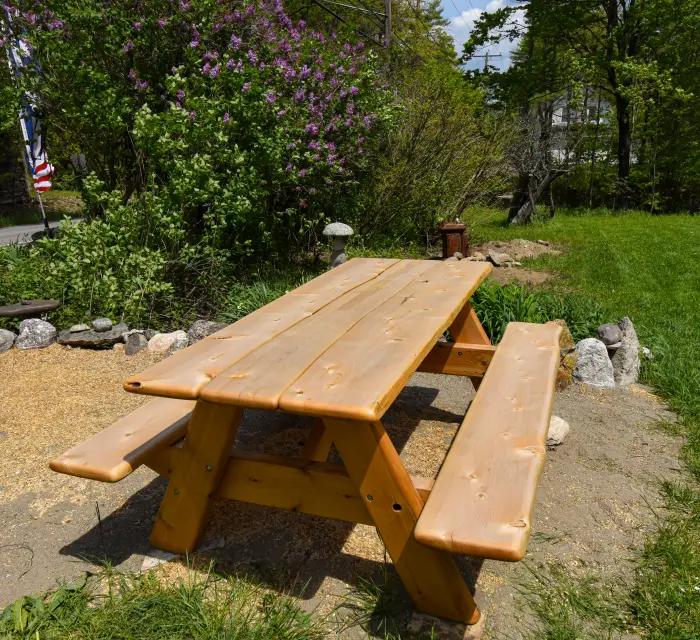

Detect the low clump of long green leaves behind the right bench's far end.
xmin=472 ymin=282 xmax=605 ymax=343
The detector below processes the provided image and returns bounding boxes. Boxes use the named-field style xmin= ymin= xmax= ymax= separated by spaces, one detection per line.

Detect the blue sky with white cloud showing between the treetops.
xmin=442 ymin=0 xmax=524 ymax=69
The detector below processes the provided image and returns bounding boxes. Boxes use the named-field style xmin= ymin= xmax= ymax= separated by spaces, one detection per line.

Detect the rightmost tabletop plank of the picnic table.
xmin=279 ymin=260 xmax=492 ymax=421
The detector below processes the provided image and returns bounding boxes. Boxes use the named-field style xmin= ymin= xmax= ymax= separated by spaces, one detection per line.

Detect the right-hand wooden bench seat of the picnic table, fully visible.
xmin=415 ymin=322 xmax=561 ymax=561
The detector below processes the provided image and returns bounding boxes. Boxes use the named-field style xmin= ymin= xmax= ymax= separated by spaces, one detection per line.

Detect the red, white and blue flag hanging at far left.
xmin=3 ymin=7 xmax=54 ymax=193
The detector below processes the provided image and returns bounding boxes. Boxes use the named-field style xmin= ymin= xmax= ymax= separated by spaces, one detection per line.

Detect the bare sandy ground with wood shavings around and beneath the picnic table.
xmin=0 ymin=347 xmax=680 ymax=638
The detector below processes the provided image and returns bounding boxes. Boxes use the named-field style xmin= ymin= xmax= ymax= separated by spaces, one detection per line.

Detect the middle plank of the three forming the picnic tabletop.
xmin=200 ymin=260 xmax=435 ymax=410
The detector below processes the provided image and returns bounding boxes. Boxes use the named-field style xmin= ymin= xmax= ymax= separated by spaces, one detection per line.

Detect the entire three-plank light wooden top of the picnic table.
xmin=124 ymin=258 xmax=492 ymax=420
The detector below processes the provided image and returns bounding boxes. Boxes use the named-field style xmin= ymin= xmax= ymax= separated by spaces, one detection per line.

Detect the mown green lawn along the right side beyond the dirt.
xmin=473 ymin=212 xmax=700 ymax=640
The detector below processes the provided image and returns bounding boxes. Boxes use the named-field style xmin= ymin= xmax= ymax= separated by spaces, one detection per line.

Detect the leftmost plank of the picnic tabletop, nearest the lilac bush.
xmin=124 ymin=258 xmax=399 ymax=400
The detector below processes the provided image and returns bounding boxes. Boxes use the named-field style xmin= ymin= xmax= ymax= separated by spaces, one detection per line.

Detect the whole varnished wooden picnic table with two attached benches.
xmin=50 ymin=259 xmax=560 ymax=623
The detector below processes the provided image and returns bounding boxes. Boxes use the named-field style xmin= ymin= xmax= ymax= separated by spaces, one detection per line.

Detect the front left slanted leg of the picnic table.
xmin=151 ymin=400 xmax=243 ymax=553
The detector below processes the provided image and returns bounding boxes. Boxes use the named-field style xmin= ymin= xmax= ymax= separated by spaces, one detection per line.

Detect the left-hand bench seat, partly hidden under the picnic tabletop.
xmin=49 ymin=398 xmax=195 ymax=482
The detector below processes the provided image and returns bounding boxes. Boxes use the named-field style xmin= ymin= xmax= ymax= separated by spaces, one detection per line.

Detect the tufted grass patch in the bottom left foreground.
xmin=0 ymin=571 xmax=324 ymax=640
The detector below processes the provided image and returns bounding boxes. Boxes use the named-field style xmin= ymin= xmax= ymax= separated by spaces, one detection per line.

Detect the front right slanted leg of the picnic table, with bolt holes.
xmin=324 ymin=418 xmax=479 ymax=624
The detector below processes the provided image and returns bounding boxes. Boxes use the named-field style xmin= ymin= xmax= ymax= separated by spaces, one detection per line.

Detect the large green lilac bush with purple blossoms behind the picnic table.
xmin=6 ymin=0 xmax=396 ymax=255
